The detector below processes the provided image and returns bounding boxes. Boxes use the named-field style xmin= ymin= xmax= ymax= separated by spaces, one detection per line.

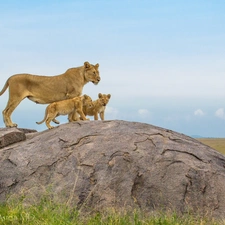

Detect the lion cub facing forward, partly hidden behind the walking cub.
xmin=70 ymin=93 xmax=111 ymax=121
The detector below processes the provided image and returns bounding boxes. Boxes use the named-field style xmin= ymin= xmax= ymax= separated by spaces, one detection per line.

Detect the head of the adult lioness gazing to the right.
xmin=84 ymin=62 xmax=101 ymax=84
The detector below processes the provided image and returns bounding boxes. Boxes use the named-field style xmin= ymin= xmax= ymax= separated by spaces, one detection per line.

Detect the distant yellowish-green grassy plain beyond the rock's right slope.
xmin=197 ymin=138 xmax=225 ymax=154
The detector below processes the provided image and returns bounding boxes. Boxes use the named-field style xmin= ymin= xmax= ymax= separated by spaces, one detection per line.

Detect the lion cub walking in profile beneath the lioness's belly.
xmin=36 ymin=95 xmax=92 ymax=129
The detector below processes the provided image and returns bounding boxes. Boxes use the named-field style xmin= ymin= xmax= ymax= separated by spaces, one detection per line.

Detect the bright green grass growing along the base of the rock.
xmin=0 ymin=199 xmax=224 ymax=225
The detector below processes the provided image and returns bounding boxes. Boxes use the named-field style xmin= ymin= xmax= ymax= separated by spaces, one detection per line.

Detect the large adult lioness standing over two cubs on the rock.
xmin=0 ymin=62 xmax=100 ymax=127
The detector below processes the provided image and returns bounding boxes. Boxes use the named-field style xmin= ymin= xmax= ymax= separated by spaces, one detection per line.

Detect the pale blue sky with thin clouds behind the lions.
xmin=0 ymin=0 xmax=225 ymax=137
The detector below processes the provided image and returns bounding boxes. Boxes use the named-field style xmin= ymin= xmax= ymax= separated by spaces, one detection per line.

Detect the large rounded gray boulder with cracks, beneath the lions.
xmin=0 ymin=121 xmax=225 ymax=217
